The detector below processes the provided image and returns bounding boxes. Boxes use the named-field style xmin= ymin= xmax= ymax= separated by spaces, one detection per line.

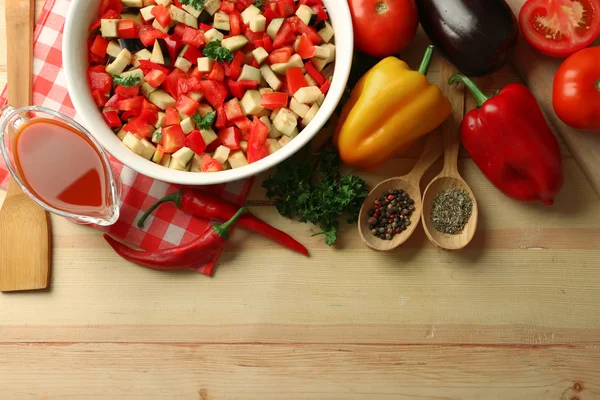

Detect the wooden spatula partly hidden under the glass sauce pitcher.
xmin=0 ymin=0 xmax=50 ymax=292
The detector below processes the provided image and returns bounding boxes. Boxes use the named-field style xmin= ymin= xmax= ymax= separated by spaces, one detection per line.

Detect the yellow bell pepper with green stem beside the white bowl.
xmin=333 ymin=46 xmax=452 ymax=169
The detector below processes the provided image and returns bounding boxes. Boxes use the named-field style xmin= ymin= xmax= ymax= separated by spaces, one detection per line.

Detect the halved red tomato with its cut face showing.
xmin=519 ymin=0 xmax=600 ymax=57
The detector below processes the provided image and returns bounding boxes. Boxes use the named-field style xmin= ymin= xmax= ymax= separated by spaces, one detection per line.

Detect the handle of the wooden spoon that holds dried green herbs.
xmin=440 ymin=59 xmax=465 ymax=175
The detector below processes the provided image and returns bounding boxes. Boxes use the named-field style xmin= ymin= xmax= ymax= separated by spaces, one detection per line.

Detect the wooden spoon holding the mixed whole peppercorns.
xmin=358 ymin=130 xmax=442 ymax=251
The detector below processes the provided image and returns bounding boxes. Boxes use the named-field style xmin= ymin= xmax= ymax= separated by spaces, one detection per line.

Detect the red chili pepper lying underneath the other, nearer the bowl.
xmin=138 ymin=188 xmax=308 ymax=256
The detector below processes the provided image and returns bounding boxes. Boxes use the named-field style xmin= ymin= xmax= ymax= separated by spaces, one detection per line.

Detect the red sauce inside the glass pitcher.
xmin=13 ymin=118 xmax=110 ymax=216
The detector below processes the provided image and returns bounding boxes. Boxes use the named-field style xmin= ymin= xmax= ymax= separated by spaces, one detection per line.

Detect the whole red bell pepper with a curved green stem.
xmin=449 ymin=74 xmax=564 ymax=205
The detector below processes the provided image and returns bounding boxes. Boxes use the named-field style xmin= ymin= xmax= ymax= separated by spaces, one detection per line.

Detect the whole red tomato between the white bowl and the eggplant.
xmin=348 ymin=0 xmax=419 ymax=57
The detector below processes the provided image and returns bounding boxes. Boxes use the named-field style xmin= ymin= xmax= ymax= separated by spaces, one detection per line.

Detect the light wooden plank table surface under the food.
xmin=0 ymin=0 xmax=600 ymax=400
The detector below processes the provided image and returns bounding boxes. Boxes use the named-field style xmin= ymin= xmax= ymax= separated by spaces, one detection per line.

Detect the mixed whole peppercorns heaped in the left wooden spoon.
xmin=367 ymin=189 xmax=415 ymax=240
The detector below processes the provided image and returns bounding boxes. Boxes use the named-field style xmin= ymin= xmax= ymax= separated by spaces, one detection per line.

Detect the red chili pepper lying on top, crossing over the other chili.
xmin=104 ymin=207 xmax=248 ymax=271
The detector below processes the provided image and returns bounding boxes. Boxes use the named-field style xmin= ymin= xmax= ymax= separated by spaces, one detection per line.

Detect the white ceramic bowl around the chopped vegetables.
xmin=63 ymin=0 xmax=354 ymax=185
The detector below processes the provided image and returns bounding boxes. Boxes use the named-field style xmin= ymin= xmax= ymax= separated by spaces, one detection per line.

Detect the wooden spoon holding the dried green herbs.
xmin=422 ymin=60 xmax=478 ymax=250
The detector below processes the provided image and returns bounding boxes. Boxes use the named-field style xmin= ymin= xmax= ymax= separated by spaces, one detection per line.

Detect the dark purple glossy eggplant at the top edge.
xmin=417 ymin=0 xmax=519 ymax=76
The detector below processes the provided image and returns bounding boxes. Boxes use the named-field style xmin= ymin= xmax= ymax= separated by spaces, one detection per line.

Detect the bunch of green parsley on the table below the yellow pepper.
xmin=263 ymin=142 xmax=369 ymax=246
